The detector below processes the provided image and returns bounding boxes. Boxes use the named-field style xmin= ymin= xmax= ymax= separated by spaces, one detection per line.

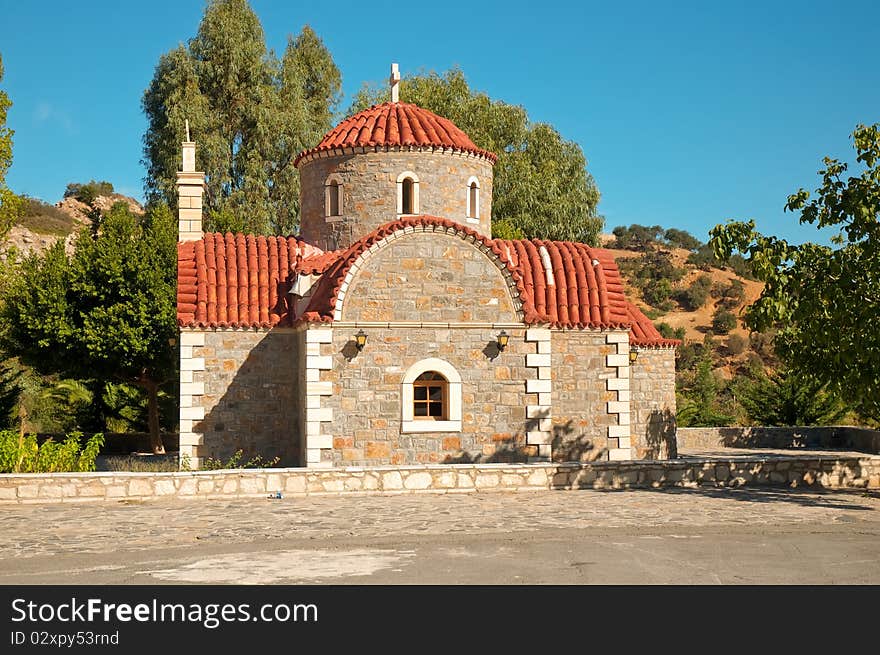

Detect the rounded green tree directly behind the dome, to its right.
xmin=351 ymin=69 xmax=603 ymax=245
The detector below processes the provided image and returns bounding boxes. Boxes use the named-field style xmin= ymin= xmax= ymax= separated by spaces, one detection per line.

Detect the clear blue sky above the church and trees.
xmin=0 ymin=0 xmax=880 ymax=242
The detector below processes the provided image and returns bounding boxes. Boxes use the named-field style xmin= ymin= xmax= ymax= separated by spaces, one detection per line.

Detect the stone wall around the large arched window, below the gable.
xmin=320 ymin=326 xmax=538 ymax=466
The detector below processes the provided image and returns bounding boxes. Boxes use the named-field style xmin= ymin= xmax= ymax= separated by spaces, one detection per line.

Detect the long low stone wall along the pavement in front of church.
xmin=0 ymin=456 xmax=880 ymax=504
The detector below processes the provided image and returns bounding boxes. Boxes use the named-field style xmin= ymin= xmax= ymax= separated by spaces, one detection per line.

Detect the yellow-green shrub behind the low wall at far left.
xmin=0 ymin=430 xmax=104 ymax=473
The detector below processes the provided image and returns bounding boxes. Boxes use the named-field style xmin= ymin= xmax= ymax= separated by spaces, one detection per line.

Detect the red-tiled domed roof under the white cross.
xmin=293 ymin=102 xmax=498 ymax=166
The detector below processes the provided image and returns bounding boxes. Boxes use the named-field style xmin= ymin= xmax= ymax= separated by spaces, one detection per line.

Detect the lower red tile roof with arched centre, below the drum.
xmin=177 ymin=216 xmax=678 ymax=347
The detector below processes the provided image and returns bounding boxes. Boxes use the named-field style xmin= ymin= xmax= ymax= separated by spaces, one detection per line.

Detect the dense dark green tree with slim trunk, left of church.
xmin=2 ymin=202 xmax=177 ymax=453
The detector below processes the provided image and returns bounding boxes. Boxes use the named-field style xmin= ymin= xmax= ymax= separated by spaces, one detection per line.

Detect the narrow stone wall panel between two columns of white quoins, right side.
xmin=550 ymin=330 xmax=619 ymax=461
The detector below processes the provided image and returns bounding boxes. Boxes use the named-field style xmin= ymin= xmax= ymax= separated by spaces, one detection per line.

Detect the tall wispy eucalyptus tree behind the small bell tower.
xmin=142 ymin=0 xmax=341 ymax=234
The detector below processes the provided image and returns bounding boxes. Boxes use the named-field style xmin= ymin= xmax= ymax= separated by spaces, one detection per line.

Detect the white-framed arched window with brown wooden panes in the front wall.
xmin=400 ymin=357 xmax=461 ymax=432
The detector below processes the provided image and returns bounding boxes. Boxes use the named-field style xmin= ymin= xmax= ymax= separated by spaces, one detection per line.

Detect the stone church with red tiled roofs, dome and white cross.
xmin=177 ymin=67 xmax=678 ymax=468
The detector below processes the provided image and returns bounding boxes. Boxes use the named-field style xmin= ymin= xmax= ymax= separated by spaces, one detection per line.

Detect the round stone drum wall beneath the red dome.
xmin=300 ymin=151 xmax=492 ymax=250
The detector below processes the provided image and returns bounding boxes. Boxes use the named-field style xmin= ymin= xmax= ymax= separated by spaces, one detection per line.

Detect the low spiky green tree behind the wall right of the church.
xmin=737 ymin=369 xmax=847 ymax=426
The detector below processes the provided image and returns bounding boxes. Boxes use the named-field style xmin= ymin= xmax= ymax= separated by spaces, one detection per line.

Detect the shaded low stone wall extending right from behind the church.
xmin=675 ymin=425 xmax=880 ymax=454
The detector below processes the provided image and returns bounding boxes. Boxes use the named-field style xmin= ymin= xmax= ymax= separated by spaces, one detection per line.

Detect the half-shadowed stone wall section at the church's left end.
xmin=187 ymin=328 xmax=304 ymax=466
